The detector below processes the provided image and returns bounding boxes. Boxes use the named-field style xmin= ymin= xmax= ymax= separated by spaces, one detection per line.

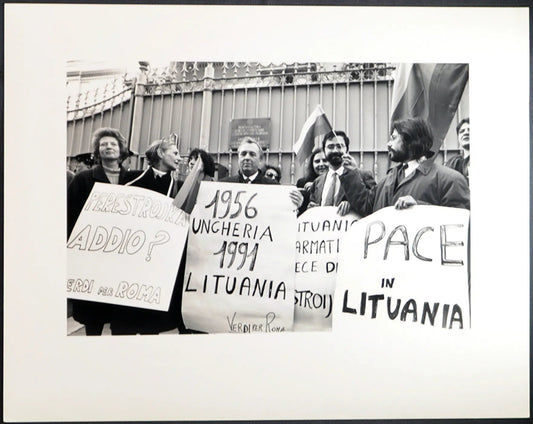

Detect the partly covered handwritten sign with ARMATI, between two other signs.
xmin=294 ymin=206 xmax=359 ymax=331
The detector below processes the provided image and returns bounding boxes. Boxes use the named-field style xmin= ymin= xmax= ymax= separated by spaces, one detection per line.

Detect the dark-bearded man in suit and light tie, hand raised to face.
xmin=309 ymin=130 xmax=376 ymax=217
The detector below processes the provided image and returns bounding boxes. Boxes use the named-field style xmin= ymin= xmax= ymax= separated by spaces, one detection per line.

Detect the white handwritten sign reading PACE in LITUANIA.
xmin=333 ymin=205 xmax=470 ymax=334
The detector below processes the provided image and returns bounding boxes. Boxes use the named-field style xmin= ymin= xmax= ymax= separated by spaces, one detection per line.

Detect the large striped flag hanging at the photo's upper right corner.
xmin=391 ymin=63 xmax=468 ymax=153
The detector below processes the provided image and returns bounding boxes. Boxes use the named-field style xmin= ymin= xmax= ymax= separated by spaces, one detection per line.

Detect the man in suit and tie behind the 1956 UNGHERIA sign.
xmin=220 ymin=137 xmax=303 ymax=208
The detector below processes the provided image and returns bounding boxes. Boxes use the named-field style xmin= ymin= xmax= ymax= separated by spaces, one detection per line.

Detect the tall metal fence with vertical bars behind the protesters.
xmin=67 ymin=62 xmax=468 ymax=183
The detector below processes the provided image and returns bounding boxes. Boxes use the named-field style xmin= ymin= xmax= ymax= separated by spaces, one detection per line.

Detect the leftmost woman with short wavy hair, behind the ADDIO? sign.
xmin=67 ymin=127 xmax=135 ymax=336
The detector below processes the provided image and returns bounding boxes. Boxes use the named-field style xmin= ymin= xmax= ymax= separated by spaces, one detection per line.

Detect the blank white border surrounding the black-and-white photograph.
xmin=4 ymin=4 xmax=529 ymax=421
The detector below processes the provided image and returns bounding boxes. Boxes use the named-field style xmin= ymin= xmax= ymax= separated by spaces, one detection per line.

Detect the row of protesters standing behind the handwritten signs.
xmin=67 ymin=118 xmax=470 ymax=335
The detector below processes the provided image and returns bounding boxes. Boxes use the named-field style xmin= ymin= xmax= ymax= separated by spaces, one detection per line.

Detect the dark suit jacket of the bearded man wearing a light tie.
xmin=310 ymin=168 xmax=376 ymax=217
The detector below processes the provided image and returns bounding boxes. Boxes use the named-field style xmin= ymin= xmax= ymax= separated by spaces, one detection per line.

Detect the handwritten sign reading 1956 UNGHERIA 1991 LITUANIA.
xmin=182 ymin=182 xmax=296 ymax=333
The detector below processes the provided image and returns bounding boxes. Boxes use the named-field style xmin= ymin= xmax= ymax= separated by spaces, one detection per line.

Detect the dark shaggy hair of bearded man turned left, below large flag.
xmin=391 ymin=118 xmax=433 ymax=159
